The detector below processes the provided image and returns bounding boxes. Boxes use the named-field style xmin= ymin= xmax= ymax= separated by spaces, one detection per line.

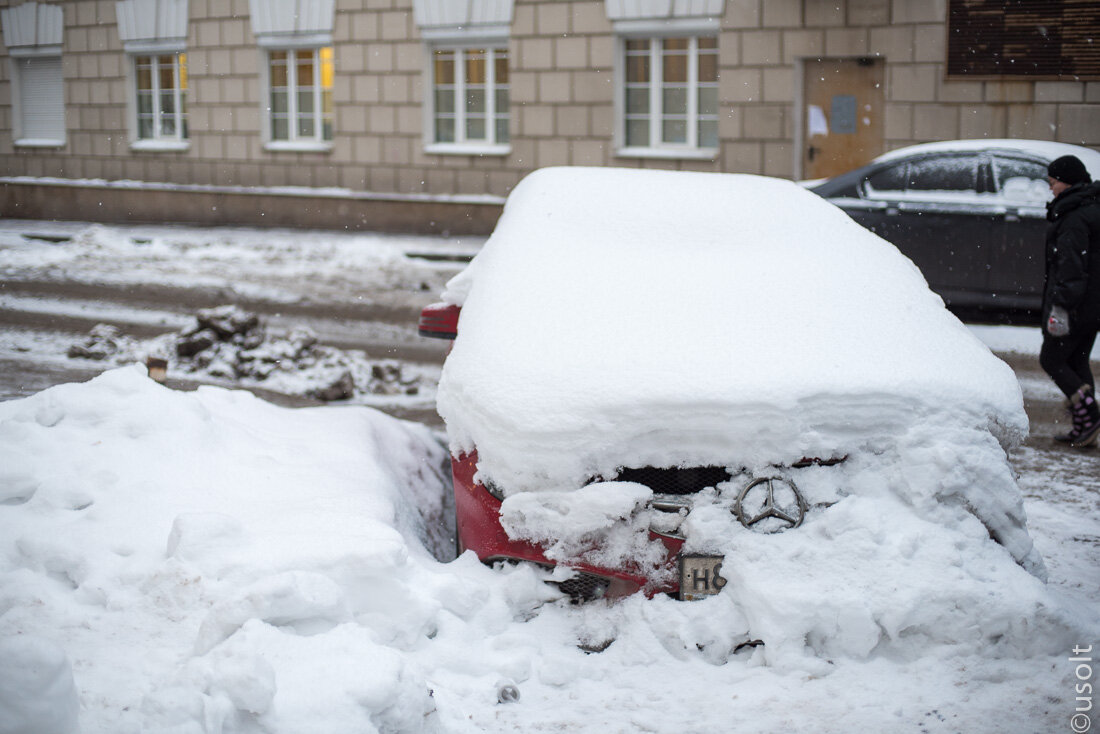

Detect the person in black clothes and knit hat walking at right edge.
xmin=1040 ymin=155 xmax=1100 ymax=448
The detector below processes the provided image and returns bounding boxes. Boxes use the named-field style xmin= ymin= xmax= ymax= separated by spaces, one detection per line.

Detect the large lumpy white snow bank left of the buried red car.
xmin=0 ymin=366 xmax=534 ymax=733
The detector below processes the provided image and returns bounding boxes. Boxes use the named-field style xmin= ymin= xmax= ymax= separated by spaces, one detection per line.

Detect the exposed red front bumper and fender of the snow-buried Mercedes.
xmin=451 ymin=452 xmax=683 ymax=596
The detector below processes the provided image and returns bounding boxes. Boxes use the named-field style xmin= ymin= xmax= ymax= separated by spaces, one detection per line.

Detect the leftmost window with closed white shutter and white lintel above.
xmin=0 ymin=2 xmax=65 ymax=146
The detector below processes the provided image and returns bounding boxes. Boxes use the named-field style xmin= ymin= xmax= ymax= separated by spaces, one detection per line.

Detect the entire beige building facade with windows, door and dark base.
xmin=0 ymin=0 xmax=1100 ymax=232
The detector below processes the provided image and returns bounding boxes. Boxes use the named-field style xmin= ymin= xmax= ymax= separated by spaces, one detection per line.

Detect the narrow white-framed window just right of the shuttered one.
xmin=131 ymin=52 xmax=188 ymax=143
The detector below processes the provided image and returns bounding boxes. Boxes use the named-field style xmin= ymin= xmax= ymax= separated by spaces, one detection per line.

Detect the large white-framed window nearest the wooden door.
xmin=619 ymin=35 xmax=718 ymax=154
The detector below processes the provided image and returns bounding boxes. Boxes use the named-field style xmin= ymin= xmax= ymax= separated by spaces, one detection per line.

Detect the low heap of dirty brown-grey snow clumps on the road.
xmin=68 ymin=305 xmax=435 ymax=402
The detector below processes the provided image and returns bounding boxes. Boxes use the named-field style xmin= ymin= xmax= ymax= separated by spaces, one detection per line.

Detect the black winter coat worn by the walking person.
xmin=1043 ymin=182 xmax=1100 ymax=327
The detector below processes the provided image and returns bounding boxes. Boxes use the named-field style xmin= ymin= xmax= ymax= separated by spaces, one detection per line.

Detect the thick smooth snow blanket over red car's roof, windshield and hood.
xmin=439 ymin=167 xmax=1026 ymax=489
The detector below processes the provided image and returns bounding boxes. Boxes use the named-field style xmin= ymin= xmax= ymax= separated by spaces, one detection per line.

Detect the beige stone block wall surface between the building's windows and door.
xmin=0 ymin=0 xmax=1100 ymax=232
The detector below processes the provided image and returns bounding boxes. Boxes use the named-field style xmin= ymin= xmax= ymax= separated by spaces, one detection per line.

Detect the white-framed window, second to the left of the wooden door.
xmin=431 ymin=47 xmax=510 ymax=147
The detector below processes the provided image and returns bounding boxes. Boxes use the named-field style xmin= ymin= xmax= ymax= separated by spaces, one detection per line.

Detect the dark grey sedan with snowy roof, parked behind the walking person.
xmin=811 ymin=140 xmax=1100 ymax=313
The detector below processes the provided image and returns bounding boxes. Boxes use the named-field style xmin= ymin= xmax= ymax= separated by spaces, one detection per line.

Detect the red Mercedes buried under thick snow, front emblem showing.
xmin=420 ymin=167 xmax=1042 ymax=599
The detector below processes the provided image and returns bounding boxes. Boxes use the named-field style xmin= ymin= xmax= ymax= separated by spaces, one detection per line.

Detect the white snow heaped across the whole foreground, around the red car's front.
xmin=0 ymin=366 xmax=1098 ymax=734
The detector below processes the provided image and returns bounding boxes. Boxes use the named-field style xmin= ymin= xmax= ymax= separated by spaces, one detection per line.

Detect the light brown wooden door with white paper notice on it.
xmin=802 ymin=58 xmax=884 ymax=178
